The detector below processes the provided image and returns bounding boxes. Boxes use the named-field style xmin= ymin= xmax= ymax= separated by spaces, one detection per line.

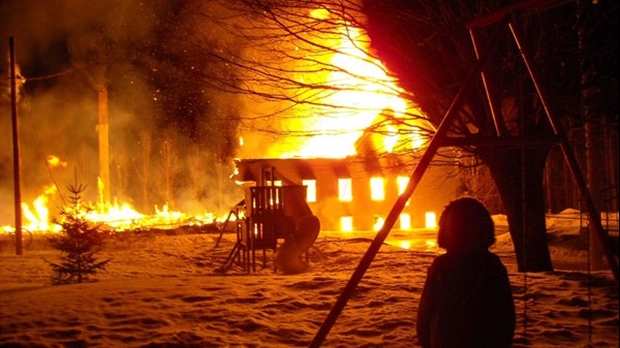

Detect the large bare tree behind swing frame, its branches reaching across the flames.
xmin=179 ymin=0 xmax=616 ymax=271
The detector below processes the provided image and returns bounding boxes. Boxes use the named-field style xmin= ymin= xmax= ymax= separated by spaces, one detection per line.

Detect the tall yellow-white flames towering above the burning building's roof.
xmin=280 ymin=10 xmax=421 ymax=158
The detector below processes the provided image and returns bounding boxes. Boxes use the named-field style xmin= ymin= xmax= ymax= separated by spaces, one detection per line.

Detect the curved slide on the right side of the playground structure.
xmin=274 ymin=186 xmax=321 ymax=274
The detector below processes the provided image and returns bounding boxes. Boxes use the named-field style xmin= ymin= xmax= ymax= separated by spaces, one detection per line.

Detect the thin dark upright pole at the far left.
xmin=9 ymin=36 xmax=24 ymax=255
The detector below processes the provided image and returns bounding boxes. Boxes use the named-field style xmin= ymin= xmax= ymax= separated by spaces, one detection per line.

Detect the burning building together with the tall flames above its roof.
xmin=234 ymin=13 xmax=462 ymax=231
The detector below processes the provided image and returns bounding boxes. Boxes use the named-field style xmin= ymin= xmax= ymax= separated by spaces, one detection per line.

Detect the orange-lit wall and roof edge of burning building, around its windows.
xmin=236 ymin=157 xmax=461 ymax=234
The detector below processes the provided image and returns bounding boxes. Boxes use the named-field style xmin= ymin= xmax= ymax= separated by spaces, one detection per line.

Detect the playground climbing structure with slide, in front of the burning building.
xmin=218 ymin=185 xmax=321 ymax=274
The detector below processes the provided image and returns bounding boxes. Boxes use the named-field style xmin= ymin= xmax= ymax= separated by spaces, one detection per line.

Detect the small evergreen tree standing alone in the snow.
xmin=45 ymin=184 xmax=110 ymax=285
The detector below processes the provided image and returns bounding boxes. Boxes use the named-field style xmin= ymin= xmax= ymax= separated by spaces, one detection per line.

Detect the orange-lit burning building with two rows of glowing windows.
xmin=234 ymin=115 xmax=462 ymax=232
